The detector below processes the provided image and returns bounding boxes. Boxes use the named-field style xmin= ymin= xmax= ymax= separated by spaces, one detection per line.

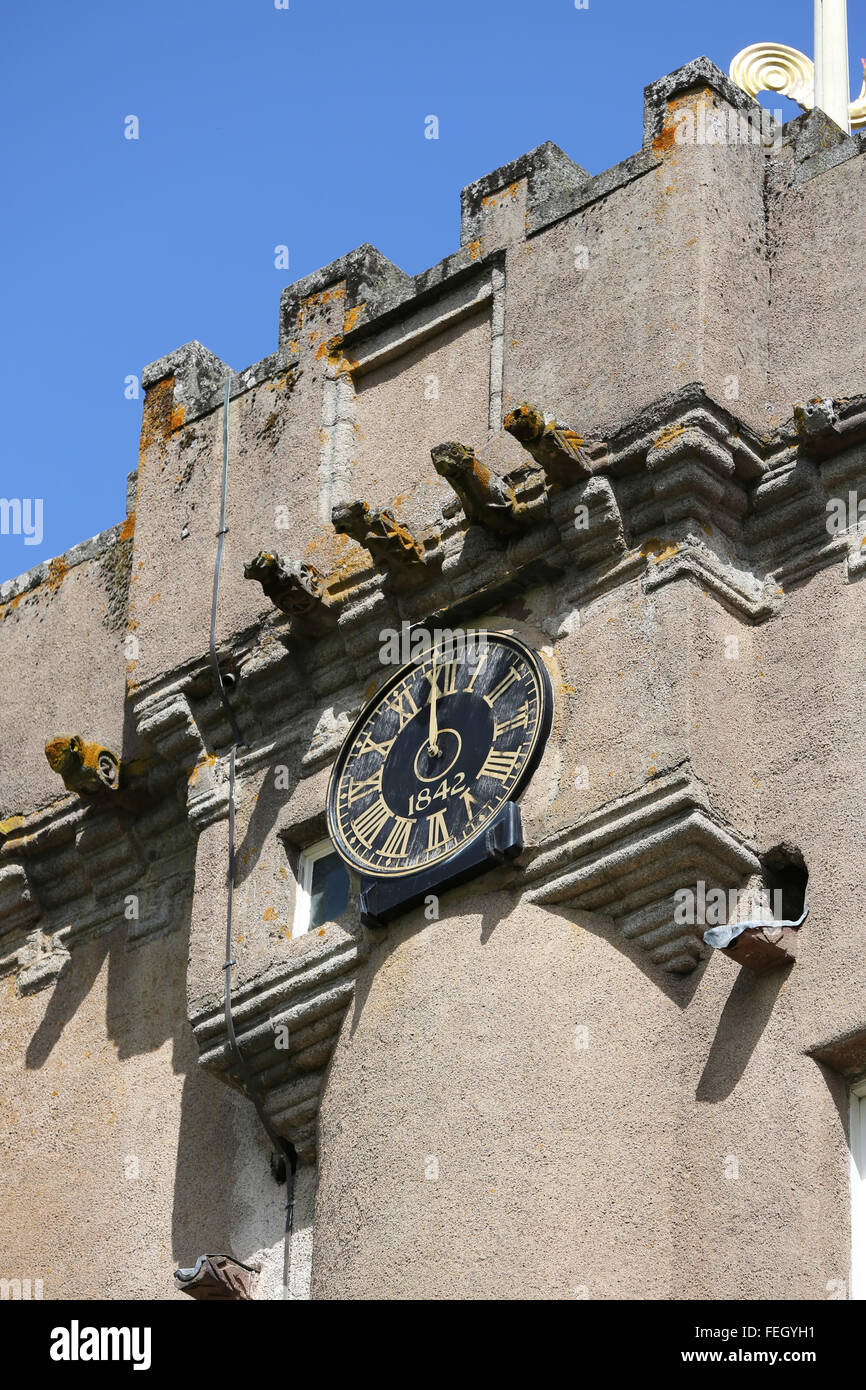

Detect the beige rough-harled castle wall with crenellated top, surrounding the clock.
xmin=0 ymin=58 xmax=866 ymax=1300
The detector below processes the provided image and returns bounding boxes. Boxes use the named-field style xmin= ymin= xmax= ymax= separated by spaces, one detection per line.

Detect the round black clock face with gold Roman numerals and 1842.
xmin=328 ymin=632 xmax=552 ymax=877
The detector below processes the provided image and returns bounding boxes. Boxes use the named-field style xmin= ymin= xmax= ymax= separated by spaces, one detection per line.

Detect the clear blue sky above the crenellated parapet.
xmin=0 ymin=0 xmax=866 ymax=580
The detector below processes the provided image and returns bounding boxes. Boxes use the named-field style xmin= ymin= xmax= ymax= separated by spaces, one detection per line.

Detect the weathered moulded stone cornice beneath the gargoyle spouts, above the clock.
xmin=116 ymin=385 xmax=866 ymax=830
